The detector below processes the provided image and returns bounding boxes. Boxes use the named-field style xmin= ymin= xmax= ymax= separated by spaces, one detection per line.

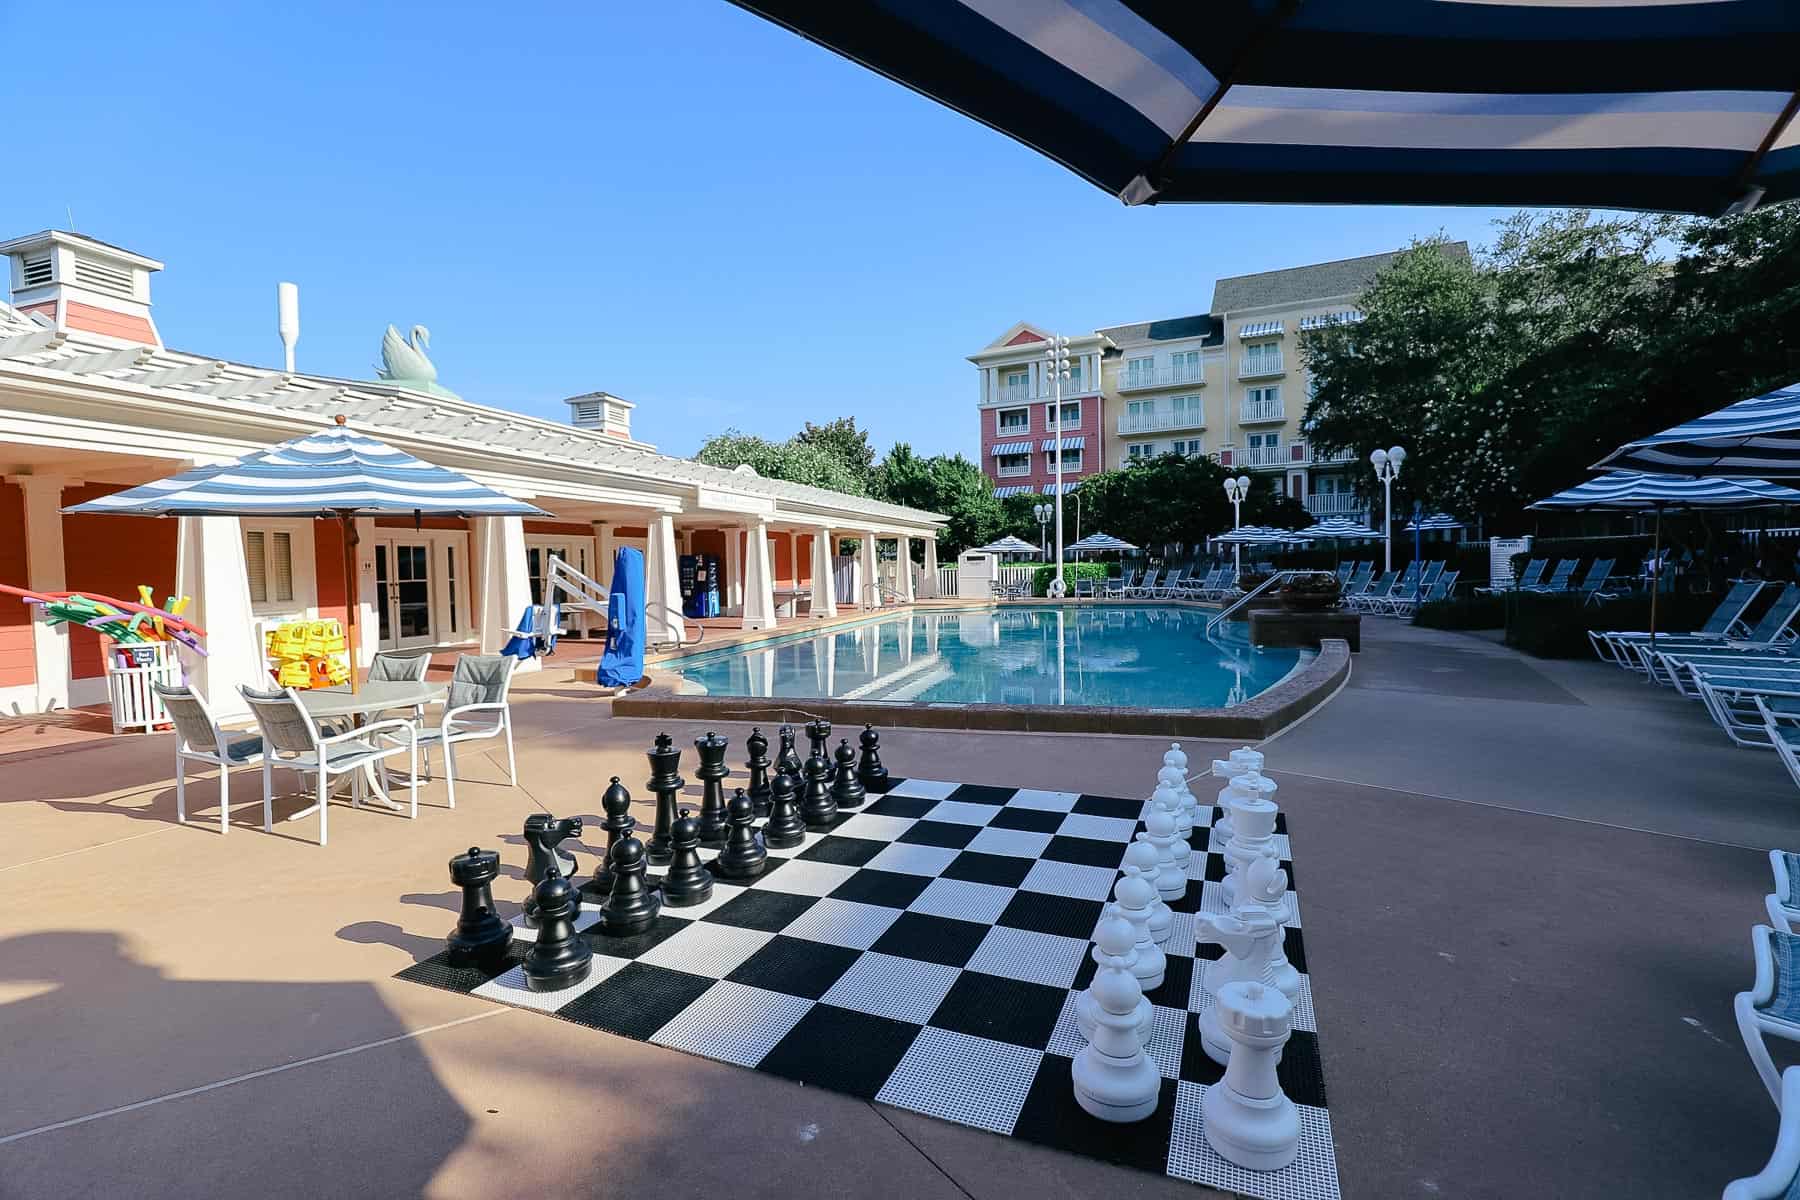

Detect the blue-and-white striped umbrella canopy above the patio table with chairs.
xmin=63 ymin=426 xmax=549 ymax=516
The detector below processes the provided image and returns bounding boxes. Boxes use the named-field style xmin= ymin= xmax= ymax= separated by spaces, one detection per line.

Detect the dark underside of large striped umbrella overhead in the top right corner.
xmin=734 ymin=0 xmax=1800 ymax=214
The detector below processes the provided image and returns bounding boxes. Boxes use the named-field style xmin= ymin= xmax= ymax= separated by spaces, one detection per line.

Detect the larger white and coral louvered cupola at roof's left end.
xmin=0 ymin=228 xmax=162 ymax=347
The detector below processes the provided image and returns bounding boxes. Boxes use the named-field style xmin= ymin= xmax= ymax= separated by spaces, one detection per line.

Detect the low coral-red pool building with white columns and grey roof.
xmin=0 ymin=232 xmax=941 ymax=712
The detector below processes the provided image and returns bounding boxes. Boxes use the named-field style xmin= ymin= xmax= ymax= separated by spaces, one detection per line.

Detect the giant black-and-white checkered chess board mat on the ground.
xmin=400 ymin=779 xmax=1339 ymax=1200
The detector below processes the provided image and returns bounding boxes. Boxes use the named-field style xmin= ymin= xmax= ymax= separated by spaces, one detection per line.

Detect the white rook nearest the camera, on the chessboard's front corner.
xmin=1201 ymin=982 xmax=1300 ymax=1171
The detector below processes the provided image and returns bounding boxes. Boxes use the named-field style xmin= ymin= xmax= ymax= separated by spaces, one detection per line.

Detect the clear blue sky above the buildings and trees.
xmin=0 ymin=0 xmax=1499 ymax=453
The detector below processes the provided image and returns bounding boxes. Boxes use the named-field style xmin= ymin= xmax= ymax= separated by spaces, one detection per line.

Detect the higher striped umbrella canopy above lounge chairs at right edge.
xmin=1595 ymin=383 xmax=1800 ymax=479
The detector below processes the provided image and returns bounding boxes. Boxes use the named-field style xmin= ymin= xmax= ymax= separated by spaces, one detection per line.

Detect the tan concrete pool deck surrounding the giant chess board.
xmin=0 ymin=621 xmax=1800 ymax=1200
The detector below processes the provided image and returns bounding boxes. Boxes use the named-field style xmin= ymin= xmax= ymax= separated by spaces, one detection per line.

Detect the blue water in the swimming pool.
xmin=661 ymin=604 xmax=1312 ymax=709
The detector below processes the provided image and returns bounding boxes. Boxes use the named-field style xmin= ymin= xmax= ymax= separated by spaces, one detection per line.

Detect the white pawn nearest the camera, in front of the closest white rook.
xmin=1069 ymin=916 xmax=1163 ymax=1123
